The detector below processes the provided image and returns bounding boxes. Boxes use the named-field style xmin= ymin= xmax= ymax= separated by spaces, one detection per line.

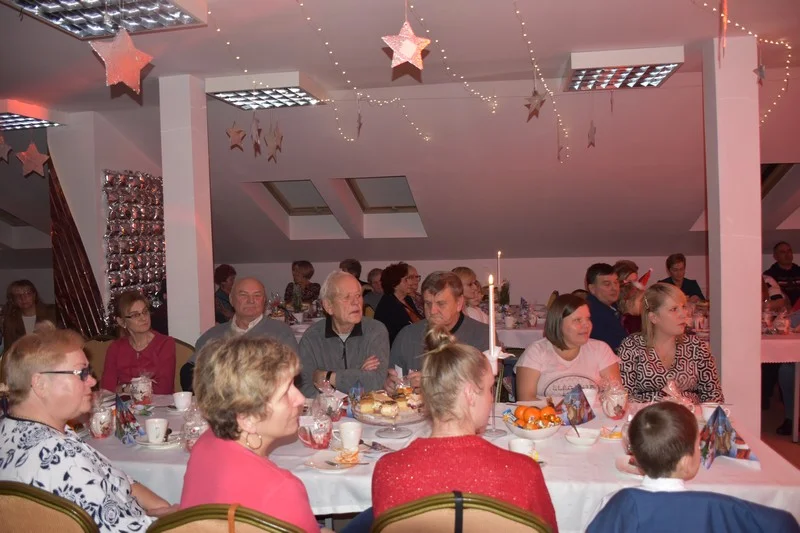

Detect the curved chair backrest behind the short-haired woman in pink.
xmin=147 ymin=504 xmax=303 ymax=533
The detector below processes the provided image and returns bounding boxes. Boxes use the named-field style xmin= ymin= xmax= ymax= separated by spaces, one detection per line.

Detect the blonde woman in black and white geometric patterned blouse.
xmin=617 ymin=283 xmax=725 ymax=403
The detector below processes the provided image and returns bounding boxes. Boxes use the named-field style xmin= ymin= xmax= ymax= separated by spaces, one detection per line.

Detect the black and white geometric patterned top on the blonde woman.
xmin=617 ymin=333 xmax=725 ymax=403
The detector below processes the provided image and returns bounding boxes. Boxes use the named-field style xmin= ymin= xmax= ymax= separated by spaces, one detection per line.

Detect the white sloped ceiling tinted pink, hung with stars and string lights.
xmin=0 ymin=0 xmax=800 ymax=263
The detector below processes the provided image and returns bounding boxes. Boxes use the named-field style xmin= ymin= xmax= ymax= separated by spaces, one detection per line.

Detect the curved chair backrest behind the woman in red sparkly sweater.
xmin=372 ymin=491 xmax=552 ymax=533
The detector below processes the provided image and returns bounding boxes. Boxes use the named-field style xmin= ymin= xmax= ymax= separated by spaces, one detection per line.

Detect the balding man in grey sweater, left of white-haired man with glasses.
xmin=181 ymin=278 xmax=298 ymax=391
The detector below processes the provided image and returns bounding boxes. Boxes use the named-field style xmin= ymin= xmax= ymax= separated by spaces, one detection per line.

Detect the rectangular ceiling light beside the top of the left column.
xmin=206 ymin=71 xmax=327 ymax=110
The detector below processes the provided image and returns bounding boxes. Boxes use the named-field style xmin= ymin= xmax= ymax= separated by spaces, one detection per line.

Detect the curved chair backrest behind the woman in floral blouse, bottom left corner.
xmin=0 ymin=481 xmax=100 ymax=533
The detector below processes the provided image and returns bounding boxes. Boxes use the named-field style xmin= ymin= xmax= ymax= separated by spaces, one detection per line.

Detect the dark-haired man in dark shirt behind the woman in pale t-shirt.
xmin=586 ymin=263 xmax=628 ymax=351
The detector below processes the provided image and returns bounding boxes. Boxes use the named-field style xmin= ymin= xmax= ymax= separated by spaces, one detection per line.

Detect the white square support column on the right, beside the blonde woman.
xmin=703 ymin=37 xmax=761 ymax=435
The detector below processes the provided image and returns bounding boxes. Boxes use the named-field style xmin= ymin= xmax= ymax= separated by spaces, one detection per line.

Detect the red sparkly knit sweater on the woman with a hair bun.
xmin=372 ymin=435 xmax=558 ymax=532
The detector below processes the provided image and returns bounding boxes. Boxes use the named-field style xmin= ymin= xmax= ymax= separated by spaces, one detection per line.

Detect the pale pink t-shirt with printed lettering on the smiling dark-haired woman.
xmin=514 ymin=338 xmax=619 ymax=397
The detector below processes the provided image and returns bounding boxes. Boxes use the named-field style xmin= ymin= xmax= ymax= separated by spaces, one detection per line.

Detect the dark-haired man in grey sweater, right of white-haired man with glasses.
xmin=384 ymin=271 xmax=489 ymax=392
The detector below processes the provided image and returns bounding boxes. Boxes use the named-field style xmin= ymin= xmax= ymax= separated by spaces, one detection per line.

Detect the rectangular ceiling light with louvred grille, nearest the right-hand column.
xmin=567 ymin=46 xmax=684 ymax=91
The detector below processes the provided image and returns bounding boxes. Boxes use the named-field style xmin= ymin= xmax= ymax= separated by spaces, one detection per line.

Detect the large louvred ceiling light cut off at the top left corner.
xmin=0 ymin=0 xmax=208 ymax=40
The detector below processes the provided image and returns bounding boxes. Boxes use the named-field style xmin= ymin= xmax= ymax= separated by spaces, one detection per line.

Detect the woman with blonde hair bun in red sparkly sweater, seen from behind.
xmin=372 ymin=328 xmax=558 ymax=531
